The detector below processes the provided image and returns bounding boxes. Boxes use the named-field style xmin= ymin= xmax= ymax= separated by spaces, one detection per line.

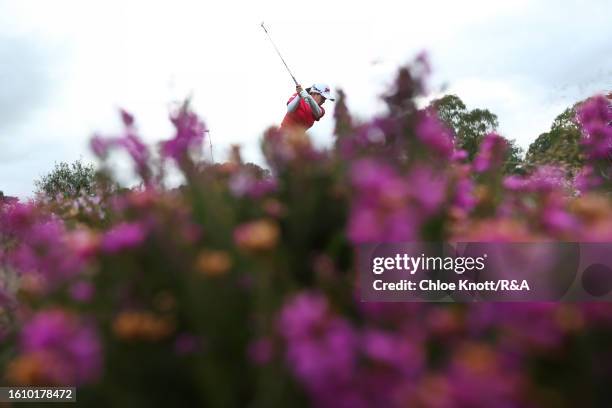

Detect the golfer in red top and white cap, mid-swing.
xmin=281 ymin=84 xmax=335 ymax=130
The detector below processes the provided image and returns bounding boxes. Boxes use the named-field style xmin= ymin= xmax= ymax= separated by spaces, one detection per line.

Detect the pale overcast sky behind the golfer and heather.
xmin=0 ymin=0 xmax=612 ymax=198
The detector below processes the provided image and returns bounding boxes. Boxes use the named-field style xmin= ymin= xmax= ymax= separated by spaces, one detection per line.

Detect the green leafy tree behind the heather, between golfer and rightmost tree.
xmin=430 ymin=95 xmax=523 ymax=173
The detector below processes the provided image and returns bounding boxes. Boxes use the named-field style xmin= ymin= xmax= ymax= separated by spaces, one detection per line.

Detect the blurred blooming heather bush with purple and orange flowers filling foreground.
xmin=0 ymin=58 xmax=612 ymax=408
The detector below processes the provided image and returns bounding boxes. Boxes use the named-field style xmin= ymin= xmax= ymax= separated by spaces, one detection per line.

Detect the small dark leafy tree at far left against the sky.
xmin=35 ymin=160 xmax=96 ymax=199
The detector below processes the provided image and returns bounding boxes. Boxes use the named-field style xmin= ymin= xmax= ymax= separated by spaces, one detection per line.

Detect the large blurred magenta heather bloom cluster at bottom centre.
xmin=279 ymin=292 xmax=424 ymax=407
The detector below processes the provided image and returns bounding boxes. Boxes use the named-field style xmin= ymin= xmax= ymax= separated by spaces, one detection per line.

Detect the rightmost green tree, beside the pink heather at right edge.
xmin=525 ymin=102 xmax=584 ymax=174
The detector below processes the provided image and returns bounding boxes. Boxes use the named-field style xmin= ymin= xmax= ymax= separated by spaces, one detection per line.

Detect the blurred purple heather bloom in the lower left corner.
xmin=20 ymin=309 xmax=102 ymax=385
